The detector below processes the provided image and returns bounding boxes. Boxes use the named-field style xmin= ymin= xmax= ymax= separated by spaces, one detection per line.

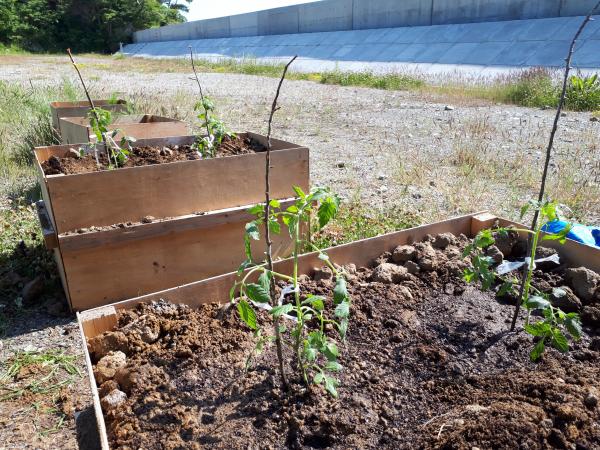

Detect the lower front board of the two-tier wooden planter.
xmin=62 ymin=217 xmax=291 ymax=310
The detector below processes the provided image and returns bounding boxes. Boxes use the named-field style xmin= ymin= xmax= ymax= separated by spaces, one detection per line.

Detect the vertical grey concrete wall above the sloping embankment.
xmin=134 ymin=0 xmax=596 ymax=42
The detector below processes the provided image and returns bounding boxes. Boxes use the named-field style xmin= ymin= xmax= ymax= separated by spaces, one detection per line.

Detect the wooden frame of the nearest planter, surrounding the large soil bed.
xmin=77 ymin=213 xmax=600 ymax=450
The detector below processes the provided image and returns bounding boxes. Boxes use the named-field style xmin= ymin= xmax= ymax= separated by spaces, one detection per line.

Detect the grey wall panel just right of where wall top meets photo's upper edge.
xmin=352 ymin=0 xmax=433 ymax=30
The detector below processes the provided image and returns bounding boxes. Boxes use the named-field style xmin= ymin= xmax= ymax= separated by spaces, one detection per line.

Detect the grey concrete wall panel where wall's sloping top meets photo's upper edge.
xmin=298 ymin=0 xmax=353 ymax=33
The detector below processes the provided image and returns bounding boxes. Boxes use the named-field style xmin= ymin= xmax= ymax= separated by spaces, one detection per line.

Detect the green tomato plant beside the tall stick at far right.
xmin=463 ymin=201 xmax=581 ymax=361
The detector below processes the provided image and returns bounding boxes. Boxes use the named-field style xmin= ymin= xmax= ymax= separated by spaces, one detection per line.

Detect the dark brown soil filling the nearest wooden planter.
xmin=89 ymin=238 xmax=600 ymax=450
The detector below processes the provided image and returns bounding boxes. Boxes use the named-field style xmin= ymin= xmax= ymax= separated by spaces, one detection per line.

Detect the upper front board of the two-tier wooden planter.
xmin=47 ymin=147 xmax=309 ymax=234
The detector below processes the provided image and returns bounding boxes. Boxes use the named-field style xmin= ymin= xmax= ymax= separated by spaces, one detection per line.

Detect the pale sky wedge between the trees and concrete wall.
xmin=186 ymin=0 xmax=318 ymax=21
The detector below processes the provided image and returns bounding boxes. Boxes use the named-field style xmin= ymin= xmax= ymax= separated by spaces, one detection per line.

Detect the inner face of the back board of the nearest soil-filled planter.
xmin=99 ymin=215 xmax=472 ymax=310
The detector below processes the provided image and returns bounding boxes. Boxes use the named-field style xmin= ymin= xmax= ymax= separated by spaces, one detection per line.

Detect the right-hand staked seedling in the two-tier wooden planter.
xmin=190 ymin=46 xmax=235 ymax=158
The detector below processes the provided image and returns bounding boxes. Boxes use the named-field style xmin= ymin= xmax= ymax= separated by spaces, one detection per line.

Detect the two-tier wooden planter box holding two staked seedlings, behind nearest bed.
xmin=35 ymin=133 xmax=309 ymax=310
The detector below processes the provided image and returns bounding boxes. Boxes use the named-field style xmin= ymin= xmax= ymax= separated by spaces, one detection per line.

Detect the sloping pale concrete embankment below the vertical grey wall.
xmin=124 ymin=16 xmax=600 ymax=74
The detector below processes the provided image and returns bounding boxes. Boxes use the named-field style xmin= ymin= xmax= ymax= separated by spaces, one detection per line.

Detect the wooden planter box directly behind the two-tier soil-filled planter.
xmin=59 ymin=114 xmax=189 ymax=144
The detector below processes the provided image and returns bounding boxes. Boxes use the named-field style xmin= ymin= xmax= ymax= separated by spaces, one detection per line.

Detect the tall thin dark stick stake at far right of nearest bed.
xmin=510 ymin=1 xmax=600 ymax=331
